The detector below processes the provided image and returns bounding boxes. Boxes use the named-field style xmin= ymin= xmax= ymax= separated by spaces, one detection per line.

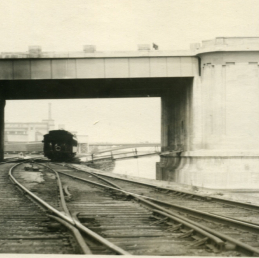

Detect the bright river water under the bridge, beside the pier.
xmin=88 ymin=155 xmax=160 ymax=179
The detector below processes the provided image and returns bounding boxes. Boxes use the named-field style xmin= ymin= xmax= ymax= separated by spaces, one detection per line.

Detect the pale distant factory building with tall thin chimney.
xmin=5 ymin=103 xmax=55 ymax=142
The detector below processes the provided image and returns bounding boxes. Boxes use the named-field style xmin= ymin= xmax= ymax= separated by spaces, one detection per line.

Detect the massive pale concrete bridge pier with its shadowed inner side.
xmin=157 ymin=39 xmax=259 ymax=189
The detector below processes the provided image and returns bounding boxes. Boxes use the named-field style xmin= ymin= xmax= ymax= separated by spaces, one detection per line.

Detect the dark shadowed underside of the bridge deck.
xmin=0 ymin=77 xmax=193 ymax=100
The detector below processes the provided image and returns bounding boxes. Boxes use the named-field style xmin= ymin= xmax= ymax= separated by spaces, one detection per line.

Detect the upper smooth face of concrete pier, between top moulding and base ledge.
xmin=202 ymin=52 xmax=259 ymax=150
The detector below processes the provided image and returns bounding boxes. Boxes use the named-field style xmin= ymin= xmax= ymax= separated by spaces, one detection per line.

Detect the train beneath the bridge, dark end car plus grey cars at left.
xmin=5 ymin=130 xmax=78 ymax=161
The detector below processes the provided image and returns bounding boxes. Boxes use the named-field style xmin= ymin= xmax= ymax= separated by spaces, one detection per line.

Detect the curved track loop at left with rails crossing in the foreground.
xmin=9 ymin=163 xmax=129 ymax=255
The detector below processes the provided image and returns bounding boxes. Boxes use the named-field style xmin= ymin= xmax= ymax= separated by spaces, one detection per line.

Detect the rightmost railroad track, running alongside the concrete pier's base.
xmin=69 ymin=165 xmax=259 ymax=224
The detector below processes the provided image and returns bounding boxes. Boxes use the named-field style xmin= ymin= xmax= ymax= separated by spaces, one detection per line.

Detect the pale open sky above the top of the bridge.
xmin=0 ymin=0 xmax=259 ymax=51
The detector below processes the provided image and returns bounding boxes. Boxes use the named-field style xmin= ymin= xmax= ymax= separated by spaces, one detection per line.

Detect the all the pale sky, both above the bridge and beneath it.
xmin=3 ymin=0 xmax=259 ymax=141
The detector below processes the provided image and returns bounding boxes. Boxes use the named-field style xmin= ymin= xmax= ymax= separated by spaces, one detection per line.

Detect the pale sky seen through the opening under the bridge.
xmin=5 ymin=98 xmax=160 ymax=142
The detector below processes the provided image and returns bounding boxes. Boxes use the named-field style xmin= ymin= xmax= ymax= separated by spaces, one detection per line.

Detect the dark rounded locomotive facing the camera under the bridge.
xmin=42 ymin=130 xmax=77 ymax=161
